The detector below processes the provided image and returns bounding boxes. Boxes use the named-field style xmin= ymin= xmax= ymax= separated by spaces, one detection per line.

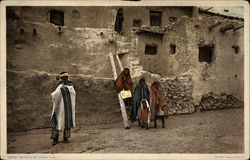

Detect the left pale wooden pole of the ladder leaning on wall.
xmin=109 ymin=52 xmax=130 ymax=129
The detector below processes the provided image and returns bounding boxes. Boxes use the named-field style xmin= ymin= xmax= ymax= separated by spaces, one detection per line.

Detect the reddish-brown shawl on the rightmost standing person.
xmin=150 ymin=82 xmax=168 ymax=120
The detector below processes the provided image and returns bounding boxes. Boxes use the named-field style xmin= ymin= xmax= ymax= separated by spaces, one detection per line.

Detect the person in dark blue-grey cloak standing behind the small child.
xmin=130 ymin=78 xmax=149 ymax=125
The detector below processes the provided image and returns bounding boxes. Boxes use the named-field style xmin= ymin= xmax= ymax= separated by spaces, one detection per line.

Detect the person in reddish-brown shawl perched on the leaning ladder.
xmin=115 ymin=68 xmax=133 ymax=108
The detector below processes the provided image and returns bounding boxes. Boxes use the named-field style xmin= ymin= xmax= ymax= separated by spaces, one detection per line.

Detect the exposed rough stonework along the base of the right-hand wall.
xmin=160 ymin=75 xmax=244 ymax=115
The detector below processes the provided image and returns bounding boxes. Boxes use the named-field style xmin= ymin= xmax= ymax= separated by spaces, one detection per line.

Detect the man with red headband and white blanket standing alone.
xmin=51 ymin=72 xmax=76 ymax=145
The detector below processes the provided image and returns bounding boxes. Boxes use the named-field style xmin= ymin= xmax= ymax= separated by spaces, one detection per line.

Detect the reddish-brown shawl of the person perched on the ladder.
xmin=115 ymin=68 xmax=133 ymax=93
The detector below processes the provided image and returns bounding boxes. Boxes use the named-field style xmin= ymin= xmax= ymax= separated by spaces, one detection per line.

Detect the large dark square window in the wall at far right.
xmin=199 ymin=46 xmax=214 ymax=63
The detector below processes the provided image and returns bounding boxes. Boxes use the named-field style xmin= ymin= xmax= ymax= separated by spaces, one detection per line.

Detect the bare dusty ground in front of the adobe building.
xmin=8 ymin=108 xmax=244 ymax=153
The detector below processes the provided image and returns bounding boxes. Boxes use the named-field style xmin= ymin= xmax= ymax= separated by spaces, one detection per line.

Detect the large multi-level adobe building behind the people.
xmin=7 ymin=6 xmax=244 ymax=131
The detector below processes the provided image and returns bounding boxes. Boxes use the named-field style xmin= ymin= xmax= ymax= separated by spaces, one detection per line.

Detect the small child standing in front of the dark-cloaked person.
xmin=140 ymin=99 xmax=151 ymax=129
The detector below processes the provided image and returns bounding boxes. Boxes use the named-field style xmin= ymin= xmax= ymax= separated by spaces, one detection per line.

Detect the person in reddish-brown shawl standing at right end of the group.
xmin=150 ymin=82 xmax=168 ymax=128
